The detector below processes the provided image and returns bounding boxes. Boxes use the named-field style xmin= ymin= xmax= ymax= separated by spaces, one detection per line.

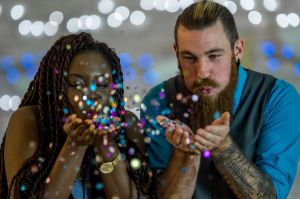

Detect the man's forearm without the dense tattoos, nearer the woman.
xmin=159 ymin=149 xmax=200 ymax=199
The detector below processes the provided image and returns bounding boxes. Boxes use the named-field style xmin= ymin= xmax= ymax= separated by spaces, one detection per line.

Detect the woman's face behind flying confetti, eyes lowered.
xmin=67 ymin=51 xmax=113 ymax=119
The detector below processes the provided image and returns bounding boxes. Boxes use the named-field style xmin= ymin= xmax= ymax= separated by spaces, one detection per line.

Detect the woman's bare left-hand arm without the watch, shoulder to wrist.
xmin=4 ymin=107 xmax=87 ymax=198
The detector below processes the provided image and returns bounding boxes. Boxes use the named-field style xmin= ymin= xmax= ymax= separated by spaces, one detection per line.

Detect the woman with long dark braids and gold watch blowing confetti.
xmin=0 ymin=33 xmax=156 ymax=199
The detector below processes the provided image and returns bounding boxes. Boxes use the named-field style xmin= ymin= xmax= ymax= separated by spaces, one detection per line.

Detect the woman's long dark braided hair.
xmin=0 ymin=32 xmax=154 ymax=198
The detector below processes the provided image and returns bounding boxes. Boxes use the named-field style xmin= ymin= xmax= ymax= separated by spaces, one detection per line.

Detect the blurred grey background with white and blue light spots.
xmin=0 ymin=0 xmax=300 ymax=199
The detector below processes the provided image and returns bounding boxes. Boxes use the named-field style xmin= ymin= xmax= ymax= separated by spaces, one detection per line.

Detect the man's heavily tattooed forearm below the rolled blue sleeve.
xmin=212 ymin=137 xmax=276 ymax=199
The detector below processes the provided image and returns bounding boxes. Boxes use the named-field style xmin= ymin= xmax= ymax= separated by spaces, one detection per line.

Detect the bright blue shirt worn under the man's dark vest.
xmin=141 ymin=66 xmax=300 ymax=198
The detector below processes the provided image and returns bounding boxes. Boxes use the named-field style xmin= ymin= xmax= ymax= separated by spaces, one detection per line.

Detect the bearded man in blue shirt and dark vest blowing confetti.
xmin=141 ymin=1 xmax=300 ymax=199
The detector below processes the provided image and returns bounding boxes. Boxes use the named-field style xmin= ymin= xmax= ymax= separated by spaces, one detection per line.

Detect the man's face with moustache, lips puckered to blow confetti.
xmin=174 ymin=21 xmax=243 ymax=101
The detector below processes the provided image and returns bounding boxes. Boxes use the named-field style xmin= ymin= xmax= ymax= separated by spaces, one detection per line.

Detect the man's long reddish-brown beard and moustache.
xmin=178 ymin=57 xmax=239 ymax=132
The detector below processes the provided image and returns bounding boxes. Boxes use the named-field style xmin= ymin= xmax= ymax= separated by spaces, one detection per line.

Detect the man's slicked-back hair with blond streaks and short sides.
xmin=174 ymin=0 xmax=239 ymax=49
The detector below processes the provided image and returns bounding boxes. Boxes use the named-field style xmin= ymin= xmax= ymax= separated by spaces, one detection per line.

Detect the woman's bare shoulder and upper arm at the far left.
xmin=4 ymin=106 xmax=39 ymax=188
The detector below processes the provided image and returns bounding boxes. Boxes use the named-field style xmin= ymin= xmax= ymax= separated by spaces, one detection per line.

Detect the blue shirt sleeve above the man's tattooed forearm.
xmin=255 ymin=80 xmax=300 ymax=199
